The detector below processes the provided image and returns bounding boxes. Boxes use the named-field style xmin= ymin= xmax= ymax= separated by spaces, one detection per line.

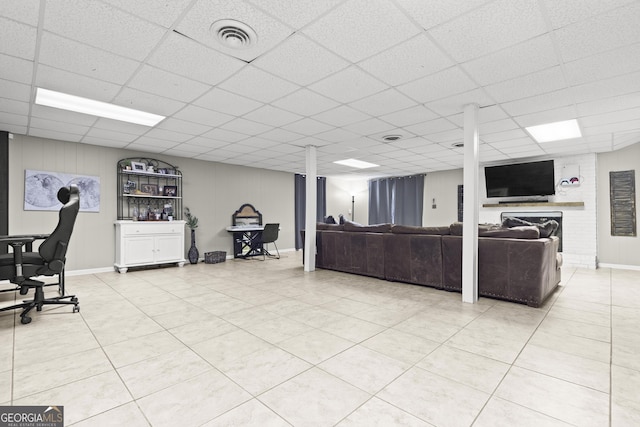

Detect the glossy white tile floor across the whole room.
xmin=0 ymin=252 xmax=640 ymax=427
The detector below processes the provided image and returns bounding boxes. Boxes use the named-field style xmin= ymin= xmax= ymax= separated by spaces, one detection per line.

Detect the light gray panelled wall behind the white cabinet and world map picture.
xmin=9 ymin=135 xmax=295 ymax=271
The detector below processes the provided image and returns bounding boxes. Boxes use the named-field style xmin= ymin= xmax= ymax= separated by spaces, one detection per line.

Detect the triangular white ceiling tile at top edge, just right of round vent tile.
xmin=250 ymin=0 xmax=343 ymax=29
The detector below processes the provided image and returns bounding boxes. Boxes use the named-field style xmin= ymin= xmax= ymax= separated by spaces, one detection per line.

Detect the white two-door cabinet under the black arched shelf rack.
xmin=114 ymin=220 xmax=185 ymax=273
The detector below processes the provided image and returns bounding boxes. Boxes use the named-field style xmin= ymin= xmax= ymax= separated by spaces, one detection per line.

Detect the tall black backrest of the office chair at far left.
xmin=38 ymin=184 xmax=80 ymax=275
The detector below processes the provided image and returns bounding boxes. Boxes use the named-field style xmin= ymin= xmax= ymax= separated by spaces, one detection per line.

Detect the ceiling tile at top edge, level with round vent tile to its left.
xmin=303 ymin=0 xmax=420 ymax=62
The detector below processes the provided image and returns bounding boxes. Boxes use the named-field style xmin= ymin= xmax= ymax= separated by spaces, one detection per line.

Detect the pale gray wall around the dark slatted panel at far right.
xmin=597 ymin=143 xmax=640 ymax=267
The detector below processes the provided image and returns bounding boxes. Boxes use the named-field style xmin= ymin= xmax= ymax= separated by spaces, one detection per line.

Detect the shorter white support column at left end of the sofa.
xmin=304 ymin=145 xmax=318 ymax=271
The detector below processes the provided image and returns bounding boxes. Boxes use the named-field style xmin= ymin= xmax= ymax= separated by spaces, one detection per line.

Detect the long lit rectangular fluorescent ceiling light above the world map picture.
xmin=36 ymin=87 xmax=165 ymax=126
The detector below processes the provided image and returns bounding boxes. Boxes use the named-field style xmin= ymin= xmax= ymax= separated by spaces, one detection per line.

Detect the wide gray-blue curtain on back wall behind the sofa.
xmin=369 ymin=175 xmax=424 ymax=226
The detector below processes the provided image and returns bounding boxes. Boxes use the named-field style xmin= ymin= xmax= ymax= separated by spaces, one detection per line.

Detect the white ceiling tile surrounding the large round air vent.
xmin=176 ymin=0 xmax=292 ymax=61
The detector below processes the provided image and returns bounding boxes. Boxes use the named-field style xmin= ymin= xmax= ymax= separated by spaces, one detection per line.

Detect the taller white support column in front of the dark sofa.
xmin=462 ymin=104 xmax=480 ymax=303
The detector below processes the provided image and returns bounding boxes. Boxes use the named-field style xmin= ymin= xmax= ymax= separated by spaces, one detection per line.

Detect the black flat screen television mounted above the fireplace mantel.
xmin=484 ymin=160 xmax=556 ymax=197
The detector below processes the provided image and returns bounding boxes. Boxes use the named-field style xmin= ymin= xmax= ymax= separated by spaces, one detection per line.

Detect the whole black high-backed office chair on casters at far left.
xmin=0 ymin=185 xmax=80 ymax=324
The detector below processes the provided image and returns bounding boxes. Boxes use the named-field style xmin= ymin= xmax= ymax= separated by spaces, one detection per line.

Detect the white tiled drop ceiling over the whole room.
xmin=0 ymin=0 xmax=640 ymax=176
